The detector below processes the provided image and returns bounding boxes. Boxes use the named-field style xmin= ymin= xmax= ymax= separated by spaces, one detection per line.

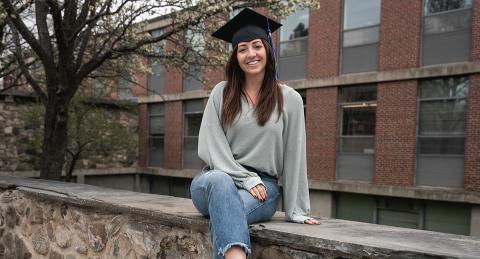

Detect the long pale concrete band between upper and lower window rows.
xmin=138 ymin=62 xmax=480 ymax=103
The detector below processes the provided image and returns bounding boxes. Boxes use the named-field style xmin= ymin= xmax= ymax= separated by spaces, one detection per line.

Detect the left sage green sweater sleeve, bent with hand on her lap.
xmin=198 ymin=82 xmax=263 ymax=191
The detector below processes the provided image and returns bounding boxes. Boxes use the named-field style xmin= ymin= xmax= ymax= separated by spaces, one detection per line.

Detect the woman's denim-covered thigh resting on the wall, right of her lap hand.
xmin=239 ymin=180 xmax=280 ymax=224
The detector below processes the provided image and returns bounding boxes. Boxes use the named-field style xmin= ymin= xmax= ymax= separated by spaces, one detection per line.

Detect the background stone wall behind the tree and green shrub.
xmin=0 ymin=98 xmax=138 ymax=174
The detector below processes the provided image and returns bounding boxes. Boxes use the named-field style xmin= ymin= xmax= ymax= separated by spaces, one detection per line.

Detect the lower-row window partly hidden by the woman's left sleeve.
xmin=183 ymin=100 xmax=203 ymax=169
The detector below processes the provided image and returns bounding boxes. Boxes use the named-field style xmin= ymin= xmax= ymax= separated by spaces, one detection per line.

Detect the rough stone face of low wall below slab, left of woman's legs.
xmin=0 ymin=190 xmax=210 ymax=259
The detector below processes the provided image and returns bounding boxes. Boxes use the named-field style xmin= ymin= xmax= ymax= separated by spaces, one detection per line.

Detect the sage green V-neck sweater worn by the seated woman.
xmin=198 ymin=82 xmax=310 ymax=223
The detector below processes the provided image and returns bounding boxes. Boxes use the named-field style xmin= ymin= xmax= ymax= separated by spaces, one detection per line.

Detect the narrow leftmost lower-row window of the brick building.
xmin=148 ymin=103 xmax=165 ymax=167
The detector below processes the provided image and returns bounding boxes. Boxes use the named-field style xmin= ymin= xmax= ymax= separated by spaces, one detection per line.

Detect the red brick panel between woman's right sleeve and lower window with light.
xmin=306 ymin=87 xmax=337 ymax=181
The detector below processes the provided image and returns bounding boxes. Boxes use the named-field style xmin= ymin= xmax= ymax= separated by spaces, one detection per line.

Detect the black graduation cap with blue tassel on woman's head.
xmin=212 ymin=8 xmax=282 ymax=79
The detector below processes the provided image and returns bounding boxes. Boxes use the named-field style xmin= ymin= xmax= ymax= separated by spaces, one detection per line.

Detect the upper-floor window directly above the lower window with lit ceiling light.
xmin=341 ymin=0 xmax=381 ymax=74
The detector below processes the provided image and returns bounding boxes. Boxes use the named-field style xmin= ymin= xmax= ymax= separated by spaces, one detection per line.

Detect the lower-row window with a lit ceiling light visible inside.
xmin=337 ymin=85 xmax=377 ymax=181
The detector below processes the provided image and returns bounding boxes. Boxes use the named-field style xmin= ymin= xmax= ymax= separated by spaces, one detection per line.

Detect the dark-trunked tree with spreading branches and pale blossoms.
xmin=0 ymin=0 xmax=318 ymax=178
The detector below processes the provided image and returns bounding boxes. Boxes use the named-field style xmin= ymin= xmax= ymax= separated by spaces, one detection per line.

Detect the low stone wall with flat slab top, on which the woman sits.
xmin=0 ymin=176 xmax=480 ymax=259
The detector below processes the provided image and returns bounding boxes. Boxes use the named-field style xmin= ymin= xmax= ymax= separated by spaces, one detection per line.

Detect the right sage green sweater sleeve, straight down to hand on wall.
xmin=283 ymin=90 xmax=310 ymax=223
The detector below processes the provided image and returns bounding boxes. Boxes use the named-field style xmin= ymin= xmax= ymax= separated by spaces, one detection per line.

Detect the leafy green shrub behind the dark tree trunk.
xmin=22 ymin=96 xmax=138 ymax=181
